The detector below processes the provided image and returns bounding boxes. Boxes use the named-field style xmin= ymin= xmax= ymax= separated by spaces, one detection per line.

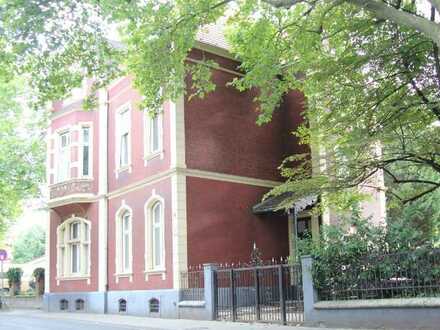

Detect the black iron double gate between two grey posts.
xmin=214 ymin=264 xmax=304 ymax=324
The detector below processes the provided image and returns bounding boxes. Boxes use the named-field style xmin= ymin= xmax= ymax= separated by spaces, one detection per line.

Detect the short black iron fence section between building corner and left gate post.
xmin=180 ymin=266 xmax=205 ymax=301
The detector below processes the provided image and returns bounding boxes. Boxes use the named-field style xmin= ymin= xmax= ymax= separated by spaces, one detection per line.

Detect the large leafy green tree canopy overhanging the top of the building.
xmin=0 ymin=0 xmax=440 ymax=209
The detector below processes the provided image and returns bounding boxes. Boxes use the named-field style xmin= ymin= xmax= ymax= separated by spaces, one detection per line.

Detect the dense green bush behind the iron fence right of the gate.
xmin=298 ymin=212 xmax=440 ymax=299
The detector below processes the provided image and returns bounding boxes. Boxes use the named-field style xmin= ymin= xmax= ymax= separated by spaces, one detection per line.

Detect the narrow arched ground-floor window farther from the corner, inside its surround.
xmin=116 ymin=207 xmax=133 ymax=274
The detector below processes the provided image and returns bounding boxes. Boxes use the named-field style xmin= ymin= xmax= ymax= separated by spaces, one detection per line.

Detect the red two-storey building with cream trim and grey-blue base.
xmin=46 ymin=27 xmax=384 ymax=317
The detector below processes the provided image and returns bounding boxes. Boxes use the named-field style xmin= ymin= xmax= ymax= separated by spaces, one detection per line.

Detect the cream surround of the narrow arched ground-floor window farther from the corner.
xmin=115 ymin=203 xmax=133 ymax=281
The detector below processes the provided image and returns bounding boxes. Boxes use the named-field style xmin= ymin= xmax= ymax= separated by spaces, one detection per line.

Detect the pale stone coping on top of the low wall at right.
xmin=313 ymin=298 xmax=440 ymax=309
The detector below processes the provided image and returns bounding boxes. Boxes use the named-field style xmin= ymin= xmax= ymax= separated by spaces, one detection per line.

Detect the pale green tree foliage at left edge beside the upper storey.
xmin=0 ymin=75 xmax=44 ymax=240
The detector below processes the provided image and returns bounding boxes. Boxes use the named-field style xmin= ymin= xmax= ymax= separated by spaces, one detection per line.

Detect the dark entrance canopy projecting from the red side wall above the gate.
xmin=252 ymin=192 xmax=318 ymax=214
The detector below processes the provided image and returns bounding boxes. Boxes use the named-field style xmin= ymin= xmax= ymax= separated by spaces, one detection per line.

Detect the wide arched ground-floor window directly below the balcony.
xmin=57 ymin=217 xmax=90 ymax=278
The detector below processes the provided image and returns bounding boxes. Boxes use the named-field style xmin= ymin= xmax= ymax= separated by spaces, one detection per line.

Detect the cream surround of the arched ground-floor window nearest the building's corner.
xmin=144 ymin=194 xmax=166 ymax=279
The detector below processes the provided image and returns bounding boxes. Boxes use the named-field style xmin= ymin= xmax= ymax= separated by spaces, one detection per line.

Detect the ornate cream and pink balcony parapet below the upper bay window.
xmin=48 ymin=179 xmax=96 ymax=208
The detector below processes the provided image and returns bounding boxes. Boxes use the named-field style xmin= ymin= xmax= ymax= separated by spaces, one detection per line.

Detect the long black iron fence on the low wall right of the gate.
xmin=315 ymin=249 xmax=440 ymax=300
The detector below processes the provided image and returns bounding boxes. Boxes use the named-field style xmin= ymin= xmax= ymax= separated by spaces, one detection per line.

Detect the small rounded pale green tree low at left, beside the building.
xmin=12 ymin=225 xmax=46 ymax=263
